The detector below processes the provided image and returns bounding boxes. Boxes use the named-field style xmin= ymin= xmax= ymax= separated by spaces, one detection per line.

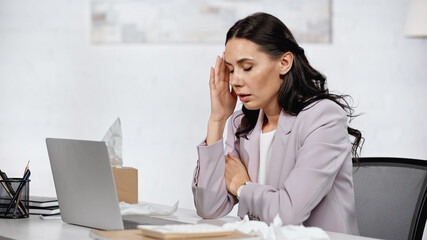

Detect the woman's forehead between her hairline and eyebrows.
xmin=224 ymin=38 xmax=268 ymax=63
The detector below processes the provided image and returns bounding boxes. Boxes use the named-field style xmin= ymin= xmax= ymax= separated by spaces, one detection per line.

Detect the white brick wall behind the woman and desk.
xmin=0 ymin=0 xmax=427 ymax=214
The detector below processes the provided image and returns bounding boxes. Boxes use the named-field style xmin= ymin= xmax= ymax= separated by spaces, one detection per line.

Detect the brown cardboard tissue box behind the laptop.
xmin=113 ymin=167 xmax=138 ymax=204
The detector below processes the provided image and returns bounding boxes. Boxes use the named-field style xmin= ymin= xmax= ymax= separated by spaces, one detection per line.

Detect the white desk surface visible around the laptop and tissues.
xmin=0 ymin=209 xmax=380 ymax=240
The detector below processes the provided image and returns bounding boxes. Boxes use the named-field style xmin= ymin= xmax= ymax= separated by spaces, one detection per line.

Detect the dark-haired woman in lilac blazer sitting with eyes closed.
xmin=192 ymin=13 xmax=361 ymax=234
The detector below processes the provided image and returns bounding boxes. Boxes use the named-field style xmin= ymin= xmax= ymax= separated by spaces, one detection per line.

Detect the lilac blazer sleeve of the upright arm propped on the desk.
xmin=192 ymin=111 xmax=239 ymax=218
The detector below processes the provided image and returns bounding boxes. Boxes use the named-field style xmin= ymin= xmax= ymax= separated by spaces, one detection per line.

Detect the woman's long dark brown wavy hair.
xmin=225 ymin=13 xmax=364 ymax=161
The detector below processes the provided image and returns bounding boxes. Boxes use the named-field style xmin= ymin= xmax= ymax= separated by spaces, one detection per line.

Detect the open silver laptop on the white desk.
xmin=46 ymin=138 xmax=184 ymax=230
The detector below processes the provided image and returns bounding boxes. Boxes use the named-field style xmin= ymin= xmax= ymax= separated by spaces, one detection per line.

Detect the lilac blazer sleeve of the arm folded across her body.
xmin=238 ymin=101 xmax=351 ymax=225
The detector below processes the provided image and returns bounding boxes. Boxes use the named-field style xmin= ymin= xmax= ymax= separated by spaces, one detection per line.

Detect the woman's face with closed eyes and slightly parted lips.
xmin=224 ymin=38 xmax=283 ymax=111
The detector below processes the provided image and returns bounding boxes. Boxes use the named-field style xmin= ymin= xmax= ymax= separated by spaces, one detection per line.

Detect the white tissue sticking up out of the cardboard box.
xmin=102 ymin=118 xmax=123 ymax=168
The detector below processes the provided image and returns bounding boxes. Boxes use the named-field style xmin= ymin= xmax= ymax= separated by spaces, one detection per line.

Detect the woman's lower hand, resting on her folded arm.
xmin=224 ymin=153 xmax=251 ymax=196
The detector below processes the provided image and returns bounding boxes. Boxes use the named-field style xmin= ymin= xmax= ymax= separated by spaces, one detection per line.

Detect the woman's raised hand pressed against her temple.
xmin=206 ymin=55 xmax=237 ymax=145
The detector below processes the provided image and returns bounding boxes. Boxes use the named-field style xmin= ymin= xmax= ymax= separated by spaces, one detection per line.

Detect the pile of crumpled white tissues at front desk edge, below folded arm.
xmin=223 ymin=215 xmax=330 ymax=240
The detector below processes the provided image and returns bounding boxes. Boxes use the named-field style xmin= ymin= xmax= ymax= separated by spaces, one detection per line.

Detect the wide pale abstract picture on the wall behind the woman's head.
xmin=90 ymin=0 xmax=331 ymax=43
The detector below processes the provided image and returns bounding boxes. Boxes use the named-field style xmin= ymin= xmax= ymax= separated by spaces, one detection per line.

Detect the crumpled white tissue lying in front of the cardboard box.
xmin=119 ymin=201 xmax=179 ymax=216
